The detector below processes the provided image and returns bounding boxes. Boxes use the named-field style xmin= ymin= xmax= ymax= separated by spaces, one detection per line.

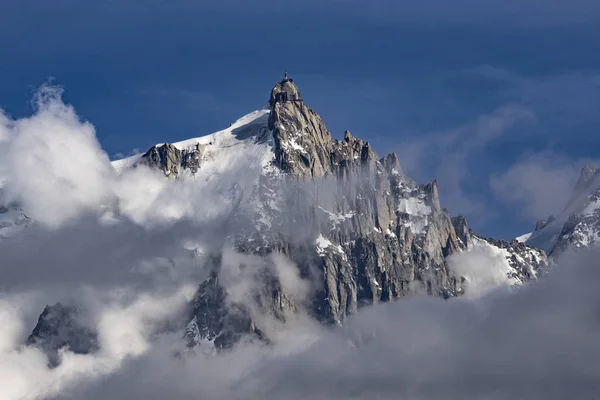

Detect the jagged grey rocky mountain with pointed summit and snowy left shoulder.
xmin=22 ymin=74 xmax=548 ymax=358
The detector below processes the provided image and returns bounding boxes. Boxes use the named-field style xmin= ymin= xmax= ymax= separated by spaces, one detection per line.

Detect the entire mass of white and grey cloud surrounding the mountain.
xmin=0 ymin=88 xmax=600 ymax=400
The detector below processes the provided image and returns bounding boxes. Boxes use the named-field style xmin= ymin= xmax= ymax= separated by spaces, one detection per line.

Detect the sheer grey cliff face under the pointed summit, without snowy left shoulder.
xmin=185 ymin=80 xmax=546 ymax=350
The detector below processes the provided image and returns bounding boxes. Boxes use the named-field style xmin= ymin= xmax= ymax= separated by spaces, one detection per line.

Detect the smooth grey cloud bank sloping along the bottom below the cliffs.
xmin=42 ymin=247 xmax=600 ymax=400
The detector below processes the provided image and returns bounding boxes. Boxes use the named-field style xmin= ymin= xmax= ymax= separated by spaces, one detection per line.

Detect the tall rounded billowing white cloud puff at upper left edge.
xmin=0 ymin=87 xmax=114 ymax=227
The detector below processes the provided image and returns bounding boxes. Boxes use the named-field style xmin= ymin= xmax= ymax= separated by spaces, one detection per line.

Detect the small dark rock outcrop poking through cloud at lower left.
xmin=27 ymin=303 xmax=98 ymax=366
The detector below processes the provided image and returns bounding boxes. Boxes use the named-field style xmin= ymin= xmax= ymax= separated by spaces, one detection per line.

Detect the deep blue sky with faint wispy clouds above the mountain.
xmin=0 ymin=0 xmax=600 ymax=238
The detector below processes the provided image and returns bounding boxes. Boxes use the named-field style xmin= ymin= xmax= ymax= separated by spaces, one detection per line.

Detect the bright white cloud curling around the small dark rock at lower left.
xmin=0 ymin=285 xmax=194 ymax=400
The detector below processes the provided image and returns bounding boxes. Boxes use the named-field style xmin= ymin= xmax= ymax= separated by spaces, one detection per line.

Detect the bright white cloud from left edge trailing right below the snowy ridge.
xmin=0 ymin=86 xmax=258 ymax=229
